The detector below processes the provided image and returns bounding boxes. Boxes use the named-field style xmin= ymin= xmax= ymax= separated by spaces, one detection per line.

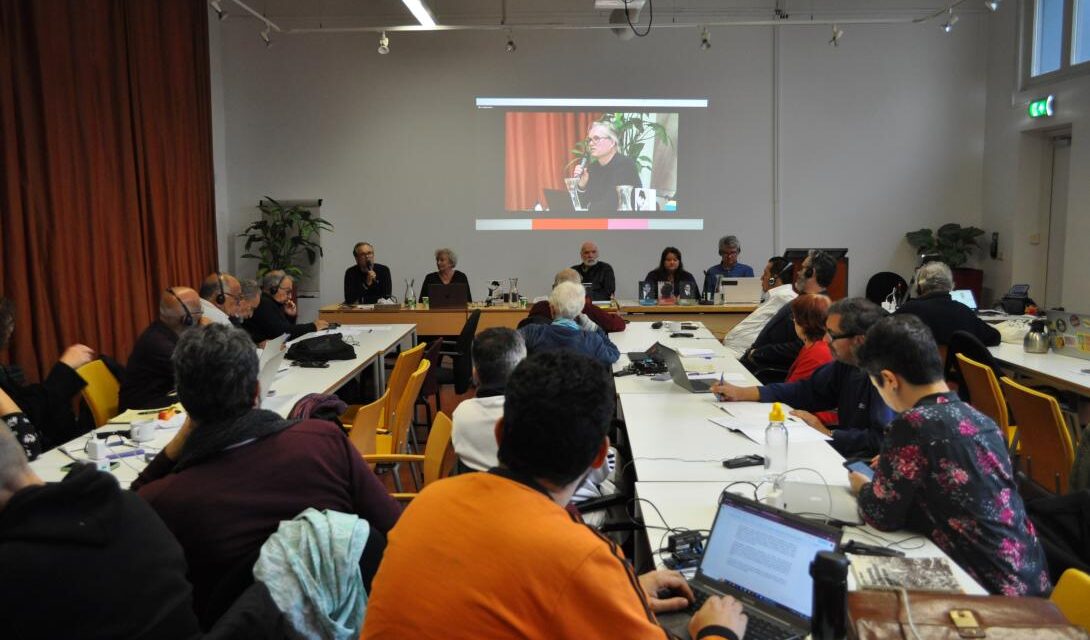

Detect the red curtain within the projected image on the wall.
xmin=504 ymin=111 xmax=602 ymax=212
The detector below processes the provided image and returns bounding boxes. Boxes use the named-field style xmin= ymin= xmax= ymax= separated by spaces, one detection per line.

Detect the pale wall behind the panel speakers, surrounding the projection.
xmin=211 ymin=14 xmax=989 ymax=303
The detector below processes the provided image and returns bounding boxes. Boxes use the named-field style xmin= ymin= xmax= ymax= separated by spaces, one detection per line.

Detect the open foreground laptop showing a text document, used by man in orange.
xmin=658 ymin=492 xmax=841 ymax=639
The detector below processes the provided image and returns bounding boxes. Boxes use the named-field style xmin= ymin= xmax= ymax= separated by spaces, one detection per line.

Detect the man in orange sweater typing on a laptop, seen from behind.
xmin=363 ymin=351 xmax=747 ymax=640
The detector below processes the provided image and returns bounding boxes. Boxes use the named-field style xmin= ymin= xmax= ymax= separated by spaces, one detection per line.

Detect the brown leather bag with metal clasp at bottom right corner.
xmin=848 ymin=590 xmax=1090 ymax=640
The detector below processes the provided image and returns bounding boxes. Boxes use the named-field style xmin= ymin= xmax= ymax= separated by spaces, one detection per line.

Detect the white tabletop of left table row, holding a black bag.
xmin=31 ymin=324 xmax=416 ymax=487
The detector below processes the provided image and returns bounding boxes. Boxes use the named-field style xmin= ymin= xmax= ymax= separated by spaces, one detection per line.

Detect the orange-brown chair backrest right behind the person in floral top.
xmin=1003 ymin=376 xmax=1075 ymax=495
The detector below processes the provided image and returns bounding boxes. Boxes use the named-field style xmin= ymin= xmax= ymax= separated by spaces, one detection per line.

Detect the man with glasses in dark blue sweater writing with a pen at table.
xmin=712 ymin=298 xmax=894 ymax=458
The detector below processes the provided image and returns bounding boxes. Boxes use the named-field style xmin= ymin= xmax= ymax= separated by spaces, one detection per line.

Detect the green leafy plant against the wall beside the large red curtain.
xmin=239 ymin=196 xmax=334 ymax=279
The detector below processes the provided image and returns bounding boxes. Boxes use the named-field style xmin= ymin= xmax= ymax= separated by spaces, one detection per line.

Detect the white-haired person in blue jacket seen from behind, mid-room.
xmin=519 ymin=282 xmax=620 ymax=364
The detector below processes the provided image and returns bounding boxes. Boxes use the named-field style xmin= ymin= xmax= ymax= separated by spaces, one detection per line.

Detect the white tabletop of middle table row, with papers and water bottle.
xmin=610 ymin=323 xmax=985 ymax=594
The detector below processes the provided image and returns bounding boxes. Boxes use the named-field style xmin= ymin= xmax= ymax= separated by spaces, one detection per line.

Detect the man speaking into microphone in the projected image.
xmin=572 ymin=122 xmax=643 ymax=212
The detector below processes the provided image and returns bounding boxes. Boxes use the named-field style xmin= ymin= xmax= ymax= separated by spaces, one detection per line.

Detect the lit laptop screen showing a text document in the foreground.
xmin=700 ymin=503 xmax=836 ymax=618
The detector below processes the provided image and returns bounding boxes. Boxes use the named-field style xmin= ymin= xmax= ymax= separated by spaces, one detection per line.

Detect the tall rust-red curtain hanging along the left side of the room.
xmin=0 ymin=0 xmax=216 ymax=379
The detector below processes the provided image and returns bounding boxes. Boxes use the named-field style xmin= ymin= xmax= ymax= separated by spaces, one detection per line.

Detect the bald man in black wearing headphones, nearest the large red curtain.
xmin=118 ymin=287 xmax=204 ymax=411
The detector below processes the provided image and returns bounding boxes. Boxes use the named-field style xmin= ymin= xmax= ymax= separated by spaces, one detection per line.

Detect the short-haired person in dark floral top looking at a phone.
xmin=850 ymin=314 xmax=1052 ymax=595
